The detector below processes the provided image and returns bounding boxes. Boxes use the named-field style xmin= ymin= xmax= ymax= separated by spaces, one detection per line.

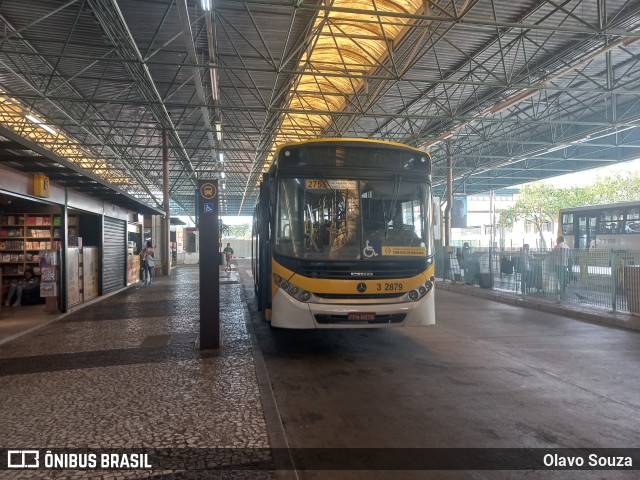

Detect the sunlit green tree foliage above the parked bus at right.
xmin=498 ymin=173 xmax=640 ymax=247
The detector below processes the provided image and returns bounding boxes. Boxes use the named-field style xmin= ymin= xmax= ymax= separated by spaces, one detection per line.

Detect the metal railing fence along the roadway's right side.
xmin=436 ymin=247 xmax=640 ymax=313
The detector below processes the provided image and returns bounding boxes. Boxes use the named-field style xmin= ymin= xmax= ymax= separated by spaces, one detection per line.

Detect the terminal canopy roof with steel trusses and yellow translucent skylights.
xmin=0 ymin=0 xmax=640 ymax=215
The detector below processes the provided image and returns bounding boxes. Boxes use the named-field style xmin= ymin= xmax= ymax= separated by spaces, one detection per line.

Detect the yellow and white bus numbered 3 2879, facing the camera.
xmin=252 ymin=139 xmax=435 ymax=329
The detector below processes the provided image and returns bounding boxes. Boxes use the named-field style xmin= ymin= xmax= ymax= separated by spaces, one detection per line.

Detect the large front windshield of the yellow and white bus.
xmin=275 ymin=176 xmax=432 ymax=261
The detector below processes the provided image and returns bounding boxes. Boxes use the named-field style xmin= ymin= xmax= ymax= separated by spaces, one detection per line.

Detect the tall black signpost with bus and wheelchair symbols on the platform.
xmin=196 ymin=180 xmax=220 ymax=350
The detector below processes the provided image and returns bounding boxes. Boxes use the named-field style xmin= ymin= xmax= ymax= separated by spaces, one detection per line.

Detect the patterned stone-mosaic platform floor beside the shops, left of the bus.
xmin=0 ymin=267 xmax=269 ymax=479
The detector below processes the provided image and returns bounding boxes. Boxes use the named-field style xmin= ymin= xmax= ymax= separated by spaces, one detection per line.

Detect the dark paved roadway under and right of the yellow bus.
xmin=240 ymin=267 xmax=640 ymax=479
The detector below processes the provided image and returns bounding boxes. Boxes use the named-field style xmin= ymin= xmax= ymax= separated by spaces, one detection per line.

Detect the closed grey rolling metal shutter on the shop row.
xmin=102 ymin=217 xmax=127 ymax=294
